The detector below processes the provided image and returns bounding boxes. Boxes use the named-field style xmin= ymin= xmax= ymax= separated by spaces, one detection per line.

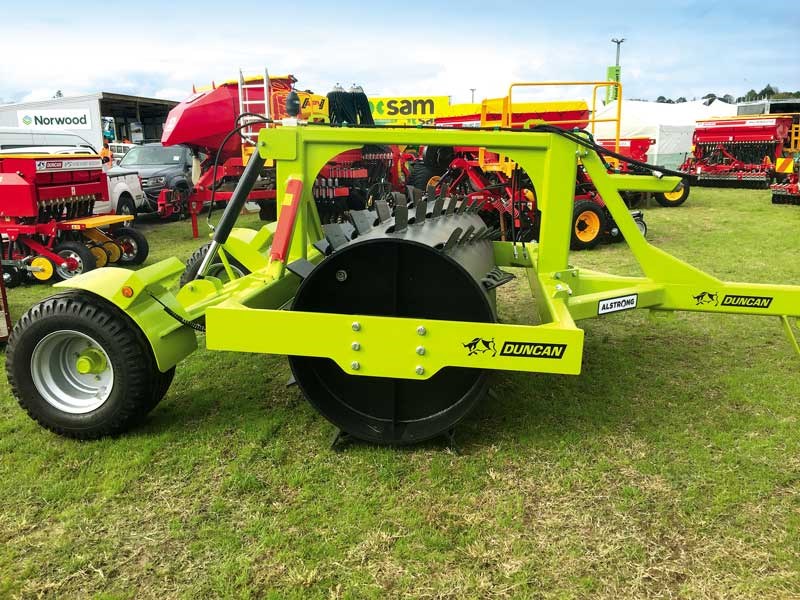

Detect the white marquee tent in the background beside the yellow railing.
xmin=595 ymin=100 xmax=736 ymax=169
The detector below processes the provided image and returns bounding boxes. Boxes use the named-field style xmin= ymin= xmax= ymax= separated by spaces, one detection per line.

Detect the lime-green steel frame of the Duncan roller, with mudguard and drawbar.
xmin=59 ymin=126 xmax=800 ymax=379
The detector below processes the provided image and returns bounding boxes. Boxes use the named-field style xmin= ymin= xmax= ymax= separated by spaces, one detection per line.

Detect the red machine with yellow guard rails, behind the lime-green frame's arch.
xmin=416 ymin=82 xmax=688 ymax=250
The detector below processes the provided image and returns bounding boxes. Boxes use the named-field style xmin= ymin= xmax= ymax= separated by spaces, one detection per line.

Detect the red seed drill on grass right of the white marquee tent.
xmin=680 ymin=114 xmax=800 ymax=195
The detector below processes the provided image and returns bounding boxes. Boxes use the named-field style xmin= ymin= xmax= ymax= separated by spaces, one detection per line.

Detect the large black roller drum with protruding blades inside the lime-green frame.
xmin=289 ymin=199 xmax=506 ymax=444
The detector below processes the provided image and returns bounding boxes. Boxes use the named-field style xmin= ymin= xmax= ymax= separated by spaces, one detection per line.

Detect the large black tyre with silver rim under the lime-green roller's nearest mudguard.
xmin=6 ymin=290 xmax=165 ymax=439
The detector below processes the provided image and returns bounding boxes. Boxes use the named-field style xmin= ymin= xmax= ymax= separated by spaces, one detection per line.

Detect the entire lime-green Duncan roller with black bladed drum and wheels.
xmin=7 ymin=124 xmax=800 ymax=444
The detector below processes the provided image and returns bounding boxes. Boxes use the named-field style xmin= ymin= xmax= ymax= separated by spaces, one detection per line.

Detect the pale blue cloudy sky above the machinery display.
xmin=0 ymin=0 xmax=800 ymax=102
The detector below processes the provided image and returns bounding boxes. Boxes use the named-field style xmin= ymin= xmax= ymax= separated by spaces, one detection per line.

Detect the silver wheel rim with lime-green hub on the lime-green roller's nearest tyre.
xmin=31 ymin=330 xmax=114 ymax=414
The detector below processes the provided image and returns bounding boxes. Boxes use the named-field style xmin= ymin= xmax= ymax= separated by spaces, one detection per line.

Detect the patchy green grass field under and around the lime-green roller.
xmin=0 ymin=189 xmax=800 ymax=599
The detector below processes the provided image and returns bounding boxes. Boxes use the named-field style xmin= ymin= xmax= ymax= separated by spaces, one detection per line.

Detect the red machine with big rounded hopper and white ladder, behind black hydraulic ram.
xmin=159 ymin=70 xmax=400 ymax=237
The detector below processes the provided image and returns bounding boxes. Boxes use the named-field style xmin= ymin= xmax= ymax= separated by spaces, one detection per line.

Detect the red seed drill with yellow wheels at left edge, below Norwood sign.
xmin=0 ymin=154 xmax=148 ymax=287
